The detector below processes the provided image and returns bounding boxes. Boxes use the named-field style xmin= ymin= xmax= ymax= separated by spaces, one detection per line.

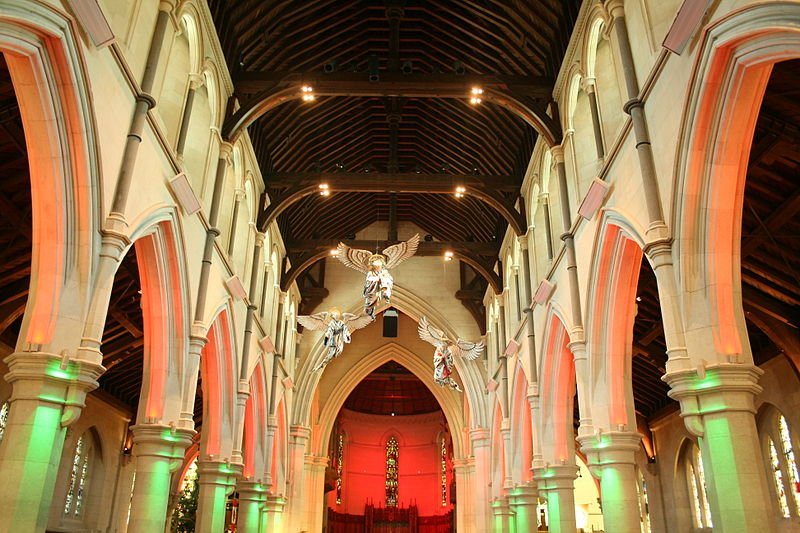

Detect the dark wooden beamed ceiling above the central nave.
xmin=209 ymin=0 xmax=581 ymax=320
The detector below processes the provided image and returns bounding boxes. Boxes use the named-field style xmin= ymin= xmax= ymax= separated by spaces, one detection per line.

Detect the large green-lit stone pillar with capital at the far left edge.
xmin=0 ymin=352 xmax=103 ymax=533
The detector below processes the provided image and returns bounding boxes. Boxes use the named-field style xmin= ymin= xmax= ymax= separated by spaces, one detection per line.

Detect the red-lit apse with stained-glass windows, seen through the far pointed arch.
xmin=325 ymin=360 xmax=455 ymax=533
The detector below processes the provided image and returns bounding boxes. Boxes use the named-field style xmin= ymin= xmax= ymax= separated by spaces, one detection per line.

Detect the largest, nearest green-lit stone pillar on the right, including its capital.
xmin=664 ymin=363 xmax=774 ymax=533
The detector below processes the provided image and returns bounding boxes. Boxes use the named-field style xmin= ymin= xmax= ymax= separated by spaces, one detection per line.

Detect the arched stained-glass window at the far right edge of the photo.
xmin=765 ymin=410 xmax=800 ymax=518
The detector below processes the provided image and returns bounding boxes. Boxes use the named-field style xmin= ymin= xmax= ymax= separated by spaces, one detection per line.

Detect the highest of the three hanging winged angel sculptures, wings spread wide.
xmin=336 ymin=234 xmax=419 ymax=318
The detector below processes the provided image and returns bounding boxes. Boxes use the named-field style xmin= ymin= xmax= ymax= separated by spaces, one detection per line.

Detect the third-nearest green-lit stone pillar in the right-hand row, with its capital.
xmin=534 ymin=464 xmax=580 ymax=533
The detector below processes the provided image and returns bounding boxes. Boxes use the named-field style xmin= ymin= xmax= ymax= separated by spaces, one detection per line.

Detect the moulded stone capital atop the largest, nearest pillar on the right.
xmin=661 ymin=363 xmax=764 ymax=437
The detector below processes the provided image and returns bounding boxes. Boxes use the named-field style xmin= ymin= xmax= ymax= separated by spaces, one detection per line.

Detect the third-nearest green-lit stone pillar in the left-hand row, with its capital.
xmin=195 ymin=459 xmax=241 ymax=533
